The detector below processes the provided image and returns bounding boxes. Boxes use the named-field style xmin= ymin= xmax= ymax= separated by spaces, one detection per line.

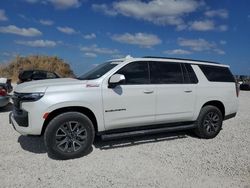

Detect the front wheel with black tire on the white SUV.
xmin=44 ymin=112 xmax=95 ymax=160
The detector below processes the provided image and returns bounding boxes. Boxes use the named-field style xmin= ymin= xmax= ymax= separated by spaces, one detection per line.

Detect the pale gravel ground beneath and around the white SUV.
xmin=0 ymin=91 xmax=250 ymax=188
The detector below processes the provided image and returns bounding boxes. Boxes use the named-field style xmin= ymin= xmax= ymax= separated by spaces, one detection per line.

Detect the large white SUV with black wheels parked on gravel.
xmin=10 ymin=57 xmax=238 ymax=159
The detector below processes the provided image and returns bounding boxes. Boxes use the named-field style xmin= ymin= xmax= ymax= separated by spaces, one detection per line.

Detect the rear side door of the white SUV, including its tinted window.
xmin=150 ymin=62 xmax=196 ymax=123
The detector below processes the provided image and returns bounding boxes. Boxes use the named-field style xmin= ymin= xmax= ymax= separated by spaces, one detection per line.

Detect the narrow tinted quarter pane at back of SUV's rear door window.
xmin=182 ymin=63 xmax=198 ymax=84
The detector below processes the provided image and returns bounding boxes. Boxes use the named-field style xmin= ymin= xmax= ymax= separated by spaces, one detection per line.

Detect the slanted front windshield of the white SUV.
xmin=78 ymin=61 xmax=118 ymax=80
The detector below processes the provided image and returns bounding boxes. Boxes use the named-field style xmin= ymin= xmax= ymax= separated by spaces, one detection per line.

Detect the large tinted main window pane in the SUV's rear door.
xmin=150 ymin=62 xmax=183 ymax=84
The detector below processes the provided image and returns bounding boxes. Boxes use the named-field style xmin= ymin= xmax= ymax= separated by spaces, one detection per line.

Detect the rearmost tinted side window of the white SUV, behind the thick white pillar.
xmin=199 ymin=65 xmax=235 ymax=82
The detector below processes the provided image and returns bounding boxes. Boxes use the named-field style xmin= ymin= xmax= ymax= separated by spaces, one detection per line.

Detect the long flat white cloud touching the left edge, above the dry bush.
xmin=0 ymin=25 xmax=42 ymax=37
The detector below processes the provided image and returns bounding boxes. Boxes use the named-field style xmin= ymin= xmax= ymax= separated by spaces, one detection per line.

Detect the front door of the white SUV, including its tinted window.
xmin=102 ymin=62 xmax=156 ymax=130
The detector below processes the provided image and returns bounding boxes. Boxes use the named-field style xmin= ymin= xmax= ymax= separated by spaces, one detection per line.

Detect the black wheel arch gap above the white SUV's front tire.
xmin=41 ymin=106 xmax=98 ymax=135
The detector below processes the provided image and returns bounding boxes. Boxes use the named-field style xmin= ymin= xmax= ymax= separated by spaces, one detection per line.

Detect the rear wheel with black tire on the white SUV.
xmin=195 ymin=105 xmax=223 ymax=139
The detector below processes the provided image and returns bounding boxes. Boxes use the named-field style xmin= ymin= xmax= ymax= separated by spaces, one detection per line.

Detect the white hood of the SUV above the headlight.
xmin=15 ymin=78 xmax=86 ymax=93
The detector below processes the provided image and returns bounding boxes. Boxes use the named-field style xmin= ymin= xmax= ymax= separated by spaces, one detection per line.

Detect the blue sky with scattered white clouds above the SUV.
xmin=0 ymin=0 xmax=250 ymax=75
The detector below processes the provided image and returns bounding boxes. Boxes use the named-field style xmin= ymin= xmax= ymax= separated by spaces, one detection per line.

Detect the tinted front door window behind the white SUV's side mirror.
xmin=117 ymin=62 xmax=149 ymax=84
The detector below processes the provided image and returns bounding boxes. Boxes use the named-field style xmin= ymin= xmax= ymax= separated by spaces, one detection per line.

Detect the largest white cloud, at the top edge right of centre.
xmin=92 ymin=0 xmax=204 ymax=27
